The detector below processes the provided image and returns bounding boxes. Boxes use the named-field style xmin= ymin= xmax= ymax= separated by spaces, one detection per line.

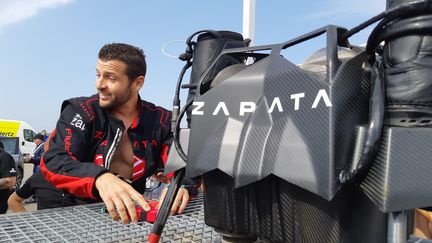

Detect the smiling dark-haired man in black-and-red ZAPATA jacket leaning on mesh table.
xmin=41 ymin=44 xmax=189 ymax=223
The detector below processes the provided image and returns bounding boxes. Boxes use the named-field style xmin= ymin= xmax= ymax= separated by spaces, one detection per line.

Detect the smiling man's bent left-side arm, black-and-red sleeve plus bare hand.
xmin=40 ymin=102 xmax=150 ymax=223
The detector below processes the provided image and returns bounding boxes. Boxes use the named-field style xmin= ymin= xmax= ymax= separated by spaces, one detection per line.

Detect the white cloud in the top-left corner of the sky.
xmin=0 ymin=0 xmax=74 ymax=28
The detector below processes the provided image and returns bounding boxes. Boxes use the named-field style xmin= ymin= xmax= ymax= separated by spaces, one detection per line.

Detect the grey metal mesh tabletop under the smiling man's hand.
xmin=0 ymin=197 xmax=222 ymax=242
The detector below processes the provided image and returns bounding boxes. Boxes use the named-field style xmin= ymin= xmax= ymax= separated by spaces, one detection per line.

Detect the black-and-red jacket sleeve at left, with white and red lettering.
xmin=40 ymin=103 xmax=107 ymax=199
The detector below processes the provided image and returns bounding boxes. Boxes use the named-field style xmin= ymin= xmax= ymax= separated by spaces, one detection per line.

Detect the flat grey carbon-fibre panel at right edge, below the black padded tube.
xmin=361 ymin=127 xmax=432 ymax=212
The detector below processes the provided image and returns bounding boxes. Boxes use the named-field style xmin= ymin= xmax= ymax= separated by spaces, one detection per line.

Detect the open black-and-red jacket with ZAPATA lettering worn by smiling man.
xmin=40 ymin=95 xmax=172 ymax=199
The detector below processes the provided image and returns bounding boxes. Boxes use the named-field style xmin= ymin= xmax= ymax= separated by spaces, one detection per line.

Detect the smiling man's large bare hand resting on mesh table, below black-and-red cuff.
xmin=95 ymin=173 xmax=150 ymax=224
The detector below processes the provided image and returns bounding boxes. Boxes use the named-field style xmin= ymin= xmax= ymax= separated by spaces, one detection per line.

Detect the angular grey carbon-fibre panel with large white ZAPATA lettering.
xmin=186 ymin=50 xmax=370 ymax=200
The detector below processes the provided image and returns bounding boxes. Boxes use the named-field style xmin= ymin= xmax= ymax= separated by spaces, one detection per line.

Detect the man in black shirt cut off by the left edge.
xmin=0 ymin=141 xmax=16 ymax=214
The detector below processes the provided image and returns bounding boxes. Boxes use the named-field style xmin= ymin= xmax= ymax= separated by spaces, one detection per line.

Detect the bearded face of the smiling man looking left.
xmin=96 ymin=59 xmax=132 ymax=109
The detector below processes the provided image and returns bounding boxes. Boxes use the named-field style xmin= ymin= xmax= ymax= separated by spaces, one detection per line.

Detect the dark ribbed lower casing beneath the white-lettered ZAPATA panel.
xmin=203 ymin=171 xmax=386 ymax=243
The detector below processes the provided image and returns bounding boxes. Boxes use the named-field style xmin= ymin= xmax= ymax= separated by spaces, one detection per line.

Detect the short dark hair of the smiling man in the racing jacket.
xmin=98 ymin=43 xmax=147 ymax=80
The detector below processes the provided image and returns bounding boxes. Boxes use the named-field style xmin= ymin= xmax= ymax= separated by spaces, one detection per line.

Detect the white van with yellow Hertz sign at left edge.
xmin=0 ymin=119 xmax=36 ymax=154
